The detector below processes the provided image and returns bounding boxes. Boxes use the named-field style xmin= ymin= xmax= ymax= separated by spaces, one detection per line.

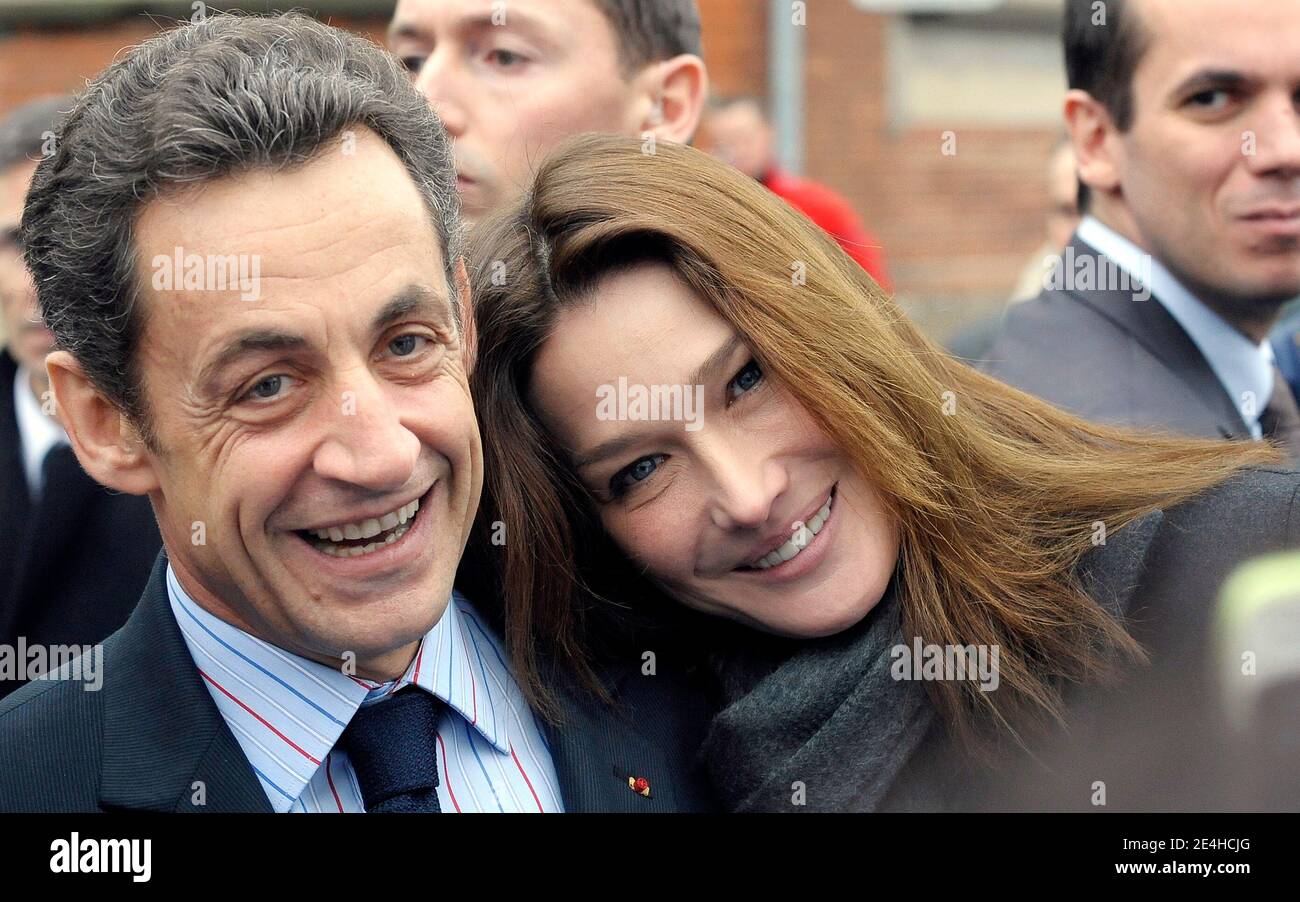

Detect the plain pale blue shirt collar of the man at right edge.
xmin=1075 ymin=216 xmax=1273 ymax=438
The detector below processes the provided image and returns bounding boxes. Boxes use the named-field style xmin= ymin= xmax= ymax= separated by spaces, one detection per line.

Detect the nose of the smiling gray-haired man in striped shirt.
xmin=315 ymin=376 xmax=420 ymax=491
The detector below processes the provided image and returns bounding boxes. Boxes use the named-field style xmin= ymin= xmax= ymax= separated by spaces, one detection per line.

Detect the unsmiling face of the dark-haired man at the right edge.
xmin=1117 ymin=0 xmax=1300 ymax=310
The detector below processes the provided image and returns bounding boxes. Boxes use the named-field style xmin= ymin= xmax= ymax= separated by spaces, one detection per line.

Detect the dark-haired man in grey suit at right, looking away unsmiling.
xmin=987 ymin=0 xmax=1300 ymax=460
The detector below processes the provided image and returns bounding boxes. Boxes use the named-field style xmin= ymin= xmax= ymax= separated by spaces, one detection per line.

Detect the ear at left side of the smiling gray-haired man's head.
xmin=46 ymin=351 xmax=159 ymax=495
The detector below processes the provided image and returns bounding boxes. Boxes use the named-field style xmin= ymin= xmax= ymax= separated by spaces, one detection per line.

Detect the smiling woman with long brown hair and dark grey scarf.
xmin=471 ymin=136 xmax=1300 ymax=810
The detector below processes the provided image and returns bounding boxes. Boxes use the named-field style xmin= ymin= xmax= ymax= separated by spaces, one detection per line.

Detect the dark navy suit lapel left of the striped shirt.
xmin=100 ymin=554 xmax=272 ymax=812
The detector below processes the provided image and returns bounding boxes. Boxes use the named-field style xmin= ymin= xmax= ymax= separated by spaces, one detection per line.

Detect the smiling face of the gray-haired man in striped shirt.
xmin=137 ymin=130 xmax=482 ymax=672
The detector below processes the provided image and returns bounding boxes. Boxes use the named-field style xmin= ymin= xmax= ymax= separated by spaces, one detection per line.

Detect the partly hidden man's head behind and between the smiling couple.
xmin=389 ymin=0 xmax=709 ymax=225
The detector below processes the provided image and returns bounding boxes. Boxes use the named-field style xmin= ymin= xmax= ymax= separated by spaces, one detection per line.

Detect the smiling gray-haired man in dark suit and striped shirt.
xmin=0 ymin=16 xmax=707 ymax=812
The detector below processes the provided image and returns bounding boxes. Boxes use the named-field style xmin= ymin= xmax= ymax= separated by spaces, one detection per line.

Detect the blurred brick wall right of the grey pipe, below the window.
xmin=805 ymin=0 xmax=1058 ymax=333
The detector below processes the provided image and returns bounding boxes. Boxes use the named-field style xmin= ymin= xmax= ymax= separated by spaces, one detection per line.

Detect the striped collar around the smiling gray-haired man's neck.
xmin=166 ymin=564 xmax=510 ymax=811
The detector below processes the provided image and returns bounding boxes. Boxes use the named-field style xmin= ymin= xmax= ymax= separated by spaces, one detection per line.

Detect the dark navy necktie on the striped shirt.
xmin=339 ymin=688 xmax=443 ymax=814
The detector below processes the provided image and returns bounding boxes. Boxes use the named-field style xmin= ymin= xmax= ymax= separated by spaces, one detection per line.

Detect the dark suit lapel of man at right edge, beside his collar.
xmin=1070 ymin=239 xmax=1251 ymax=438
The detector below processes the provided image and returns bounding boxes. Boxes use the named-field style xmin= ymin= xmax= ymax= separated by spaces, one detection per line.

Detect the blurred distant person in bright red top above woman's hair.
xmin=701 ymin=97 xmax=891 ymax=291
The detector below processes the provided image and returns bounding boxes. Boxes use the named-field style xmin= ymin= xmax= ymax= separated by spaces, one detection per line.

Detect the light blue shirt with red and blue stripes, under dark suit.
xmin=166 ymin=565 xmax=564 ymax=812
